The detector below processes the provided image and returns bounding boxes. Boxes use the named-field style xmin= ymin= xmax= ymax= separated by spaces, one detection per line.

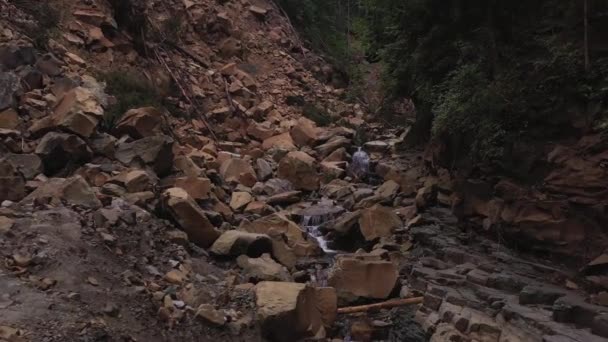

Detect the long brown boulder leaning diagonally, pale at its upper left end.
xmin=162 ymin=188 xmax=220 ymax=248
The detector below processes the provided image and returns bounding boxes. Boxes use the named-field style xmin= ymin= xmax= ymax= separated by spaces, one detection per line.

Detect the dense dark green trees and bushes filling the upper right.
xmin=278 ymin=0 xmax=608 ymax=165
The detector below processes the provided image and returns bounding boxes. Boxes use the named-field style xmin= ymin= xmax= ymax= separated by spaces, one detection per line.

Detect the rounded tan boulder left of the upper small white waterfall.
xmin=278 ymin=151 xmax=319 ymax=191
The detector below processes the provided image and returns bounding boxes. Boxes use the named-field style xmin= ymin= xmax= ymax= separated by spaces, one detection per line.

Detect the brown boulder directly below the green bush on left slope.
xmin=114 ymin=107 xmax=164 ymax=139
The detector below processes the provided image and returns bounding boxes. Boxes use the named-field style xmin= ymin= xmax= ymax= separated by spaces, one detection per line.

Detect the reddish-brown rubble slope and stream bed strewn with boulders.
xmin=0 ymin=0 xmax=608 ymax=342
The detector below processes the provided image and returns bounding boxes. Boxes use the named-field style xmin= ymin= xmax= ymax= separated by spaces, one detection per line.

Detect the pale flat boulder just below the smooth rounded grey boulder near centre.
xmin=236 ymin=254 xmax=291 ymax=282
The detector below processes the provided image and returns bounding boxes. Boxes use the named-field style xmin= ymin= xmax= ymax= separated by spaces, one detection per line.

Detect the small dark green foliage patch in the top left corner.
xmin=13 ymin=0 xmax=61 ymax=49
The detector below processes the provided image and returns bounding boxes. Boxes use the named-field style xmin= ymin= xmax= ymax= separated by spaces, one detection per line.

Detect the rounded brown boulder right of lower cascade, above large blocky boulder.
xmin=359 ymin=205 xmax=403 ymax=241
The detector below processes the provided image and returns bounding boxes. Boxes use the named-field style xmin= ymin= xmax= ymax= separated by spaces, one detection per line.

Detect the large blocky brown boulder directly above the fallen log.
xmin=328 ymin=254 xmax=399 ymax=300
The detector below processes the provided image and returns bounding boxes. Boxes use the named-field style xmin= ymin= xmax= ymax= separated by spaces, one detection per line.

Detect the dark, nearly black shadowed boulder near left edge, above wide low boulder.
xmin=36 ymin=132 xmax=93 ymax=175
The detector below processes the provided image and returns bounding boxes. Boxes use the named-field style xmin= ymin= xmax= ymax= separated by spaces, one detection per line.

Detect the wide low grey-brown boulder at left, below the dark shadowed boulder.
xmin=21 ymin=176 xmax=101 ymax=208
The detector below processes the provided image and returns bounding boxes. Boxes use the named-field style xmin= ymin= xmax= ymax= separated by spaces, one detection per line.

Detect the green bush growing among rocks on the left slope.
xmin=101 ymin=71 xmax=163 ymax=130
